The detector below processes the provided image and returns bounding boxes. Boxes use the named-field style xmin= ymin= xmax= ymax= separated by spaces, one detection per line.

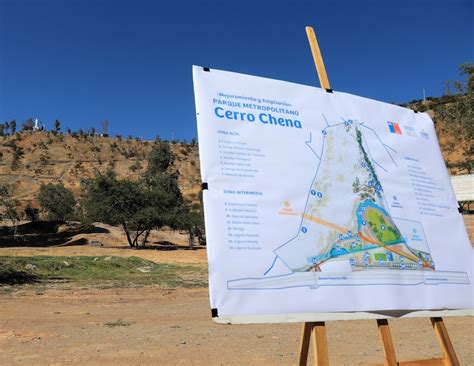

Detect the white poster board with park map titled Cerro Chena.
xmin=193 ymin=66 xmax=473 ymax=322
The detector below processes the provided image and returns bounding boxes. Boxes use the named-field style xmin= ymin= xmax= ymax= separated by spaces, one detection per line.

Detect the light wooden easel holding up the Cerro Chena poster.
xmin=298 ymin=27 xmax=460 ymax=366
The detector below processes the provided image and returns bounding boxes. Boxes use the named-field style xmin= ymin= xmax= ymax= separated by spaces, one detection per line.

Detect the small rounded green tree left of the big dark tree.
xmin=38 ymin=183 xmax=76 ymax=221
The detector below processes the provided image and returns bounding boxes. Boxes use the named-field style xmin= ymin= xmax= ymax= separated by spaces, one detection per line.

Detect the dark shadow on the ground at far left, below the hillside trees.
xmin=0 ymin=221 xmax=109 ymax=248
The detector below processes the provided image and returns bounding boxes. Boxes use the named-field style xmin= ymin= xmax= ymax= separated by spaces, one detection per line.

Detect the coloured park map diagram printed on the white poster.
xmin=228 ymin=116 xmax=469 ymax=289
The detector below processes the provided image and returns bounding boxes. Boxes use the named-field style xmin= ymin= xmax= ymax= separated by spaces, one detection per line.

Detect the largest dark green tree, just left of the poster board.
xmin=81 ymin=141 xmax=189 ymax=247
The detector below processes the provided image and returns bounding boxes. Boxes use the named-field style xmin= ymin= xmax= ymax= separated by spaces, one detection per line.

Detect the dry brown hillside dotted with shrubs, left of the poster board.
xmin=0 ymin=132 xmax=200 ymax=206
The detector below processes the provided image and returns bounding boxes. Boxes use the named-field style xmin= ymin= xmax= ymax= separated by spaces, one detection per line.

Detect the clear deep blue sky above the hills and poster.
xmin=0 ymin=0 xmax=474 ymax=140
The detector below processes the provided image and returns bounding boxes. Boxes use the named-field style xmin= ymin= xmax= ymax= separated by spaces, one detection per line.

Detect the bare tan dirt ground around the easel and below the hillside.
xmin=0 ymin=217 xmax=474 ymax=366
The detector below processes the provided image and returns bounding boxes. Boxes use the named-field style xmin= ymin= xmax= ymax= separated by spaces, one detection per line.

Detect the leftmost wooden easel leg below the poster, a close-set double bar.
xmin=298 ymin=322 xmax=329 ymax=366
